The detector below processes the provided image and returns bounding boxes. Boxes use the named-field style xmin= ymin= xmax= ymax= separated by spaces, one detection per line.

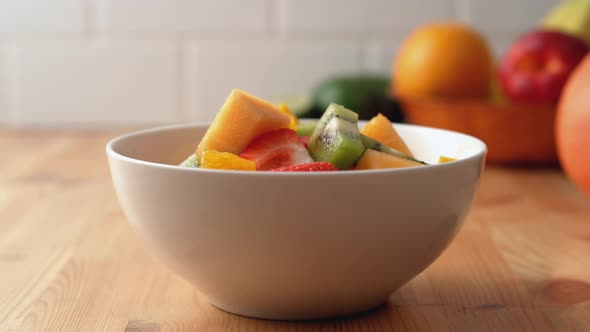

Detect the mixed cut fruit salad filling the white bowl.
xmin=180 ymin=89 xmax=452 ymax=172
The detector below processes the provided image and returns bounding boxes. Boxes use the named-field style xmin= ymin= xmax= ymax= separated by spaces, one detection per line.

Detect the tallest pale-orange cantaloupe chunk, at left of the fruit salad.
xmin=196 ymin=89 xmax=291 ymax=158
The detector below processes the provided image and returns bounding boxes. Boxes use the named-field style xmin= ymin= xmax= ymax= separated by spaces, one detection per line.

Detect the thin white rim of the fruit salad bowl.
xmin=105 ymin=119 xmax=488 ymax=177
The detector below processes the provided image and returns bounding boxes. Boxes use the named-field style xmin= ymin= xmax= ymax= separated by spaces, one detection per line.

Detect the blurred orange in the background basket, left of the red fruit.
xmin=392 ymin=23 xmax=494 ymax=98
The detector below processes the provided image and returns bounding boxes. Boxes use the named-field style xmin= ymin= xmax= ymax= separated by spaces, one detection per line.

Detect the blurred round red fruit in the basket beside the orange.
xmin=500 ymin=30 xmax=588 ymax=103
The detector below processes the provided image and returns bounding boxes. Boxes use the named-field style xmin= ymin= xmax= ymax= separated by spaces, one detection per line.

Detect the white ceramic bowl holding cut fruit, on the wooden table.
xmin=107 ymin=124 xmax=486 ymax=319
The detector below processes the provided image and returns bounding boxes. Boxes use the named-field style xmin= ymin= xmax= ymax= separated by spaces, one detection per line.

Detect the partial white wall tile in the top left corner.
xmin=0 ymin=0 xmax=85 ymax=38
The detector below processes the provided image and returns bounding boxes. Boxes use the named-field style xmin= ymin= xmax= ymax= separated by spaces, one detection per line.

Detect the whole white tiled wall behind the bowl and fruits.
xmin=0 ymin=0 xmax=558 ymax=127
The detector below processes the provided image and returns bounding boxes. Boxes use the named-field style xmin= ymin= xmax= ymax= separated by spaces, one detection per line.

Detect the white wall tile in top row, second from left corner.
xmin=96 ymin=0 xmax=268 ymax=33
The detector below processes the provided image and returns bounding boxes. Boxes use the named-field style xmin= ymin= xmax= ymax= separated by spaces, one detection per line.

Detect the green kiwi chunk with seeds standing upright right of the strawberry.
xmin=308 ymin=104 xmax=365 ymax=170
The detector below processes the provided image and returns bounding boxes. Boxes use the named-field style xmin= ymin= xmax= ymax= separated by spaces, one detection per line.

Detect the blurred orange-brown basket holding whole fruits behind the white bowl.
xmin=402 ymin=100 xmax=557 ymax=164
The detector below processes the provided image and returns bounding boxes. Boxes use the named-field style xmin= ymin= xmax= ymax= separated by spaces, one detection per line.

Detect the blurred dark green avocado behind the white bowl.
xmin=309 ymin=74 xmax=403 ymax=122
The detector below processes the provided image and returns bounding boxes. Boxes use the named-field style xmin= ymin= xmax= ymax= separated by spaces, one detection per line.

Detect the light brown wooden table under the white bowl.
xmin=0 ymin=129 xmax=590 ymax=332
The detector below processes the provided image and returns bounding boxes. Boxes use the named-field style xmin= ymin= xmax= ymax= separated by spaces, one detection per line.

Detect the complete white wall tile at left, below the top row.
xmin=7 ymin=42 xmax=179 ymax=125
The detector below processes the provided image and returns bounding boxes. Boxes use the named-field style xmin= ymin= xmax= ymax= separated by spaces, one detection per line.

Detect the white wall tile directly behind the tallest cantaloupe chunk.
xmin=185 ymin=42 xmax=360 ymax=120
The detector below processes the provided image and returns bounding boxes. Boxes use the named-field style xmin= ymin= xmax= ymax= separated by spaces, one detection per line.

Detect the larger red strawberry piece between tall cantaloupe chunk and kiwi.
xmin=240 ymin=128 xmax=313 ymax=171
